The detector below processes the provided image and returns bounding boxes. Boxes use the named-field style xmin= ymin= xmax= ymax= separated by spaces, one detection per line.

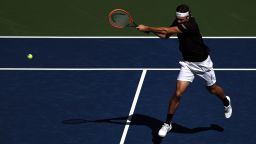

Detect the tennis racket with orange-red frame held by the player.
xmin=108 ymin=9 xmax=138 ymax=29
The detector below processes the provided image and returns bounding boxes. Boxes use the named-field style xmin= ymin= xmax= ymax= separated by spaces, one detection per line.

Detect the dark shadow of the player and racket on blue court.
xmin=62 ymin=114 xmax=224 ymax=144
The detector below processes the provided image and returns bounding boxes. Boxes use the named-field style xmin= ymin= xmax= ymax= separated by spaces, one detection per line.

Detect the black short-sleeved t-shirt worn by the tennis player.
xmin=171 ymin=17 xmax=209 ymax=62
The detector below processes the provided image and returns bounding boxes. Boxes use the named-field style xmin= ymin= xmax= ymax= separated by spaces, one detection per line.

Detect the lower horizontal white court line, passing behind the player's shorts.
xmin=0 ymin=68 xmax=256 ymax=71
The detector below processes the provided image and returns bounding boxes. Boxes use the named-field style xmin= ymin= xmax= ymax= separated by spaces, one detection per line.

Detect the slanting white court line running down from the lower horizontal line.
xmin=120 ymin=70 xmax=147 ymax=144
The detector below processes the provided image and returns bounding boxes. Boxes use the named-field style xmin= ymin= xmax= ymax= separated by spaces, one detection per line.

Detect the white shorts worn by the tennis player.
xmin=177 ymin=56 xmax=216 ymax=86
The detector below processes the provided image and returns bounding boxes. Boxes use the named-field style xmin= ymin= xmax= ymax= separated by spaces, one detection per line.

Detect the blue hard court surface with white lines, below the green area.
xmin=0 ymin=37 xmax=256 ymax=144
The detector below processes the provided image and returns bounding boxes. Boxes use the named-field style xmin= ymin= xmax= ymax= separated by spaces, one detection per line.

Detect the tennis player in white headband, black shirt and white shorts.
xmin=137 ymin=4 xmax=232 ymax=137
